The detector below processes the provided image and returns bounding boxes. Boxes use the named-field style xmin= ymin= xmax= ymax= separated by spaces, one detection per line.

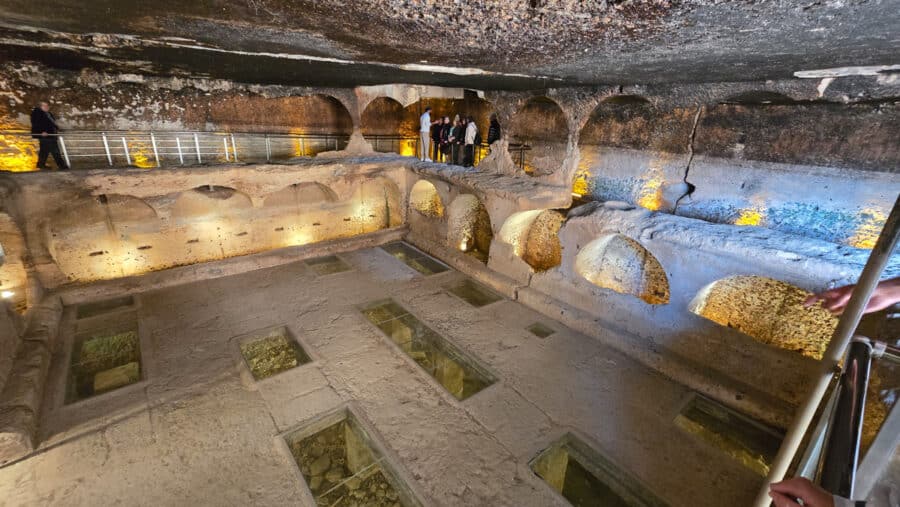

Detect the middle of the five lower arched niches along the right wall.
xmin=500 ymin=210 xmax=565 ymax=271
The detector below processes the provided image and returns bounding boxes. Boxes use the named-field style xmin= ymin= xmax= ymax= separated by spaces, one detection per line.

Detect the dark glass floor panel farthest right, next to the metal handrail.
xmin=675 ymin=395 xmax=784 ymax=477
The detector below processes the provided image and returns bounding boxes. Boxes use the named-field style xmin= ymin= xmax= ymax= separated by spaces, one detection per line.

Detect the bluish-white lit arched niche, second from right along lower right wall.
xmin=575 ymin=234 xmax=669 ymax=305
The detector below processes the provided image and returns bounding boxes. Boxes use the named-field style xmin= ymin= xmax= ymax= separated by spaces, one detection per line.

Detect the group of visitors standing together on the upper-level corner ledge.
xmin=419 ymin=107 xmax=500 ymax=167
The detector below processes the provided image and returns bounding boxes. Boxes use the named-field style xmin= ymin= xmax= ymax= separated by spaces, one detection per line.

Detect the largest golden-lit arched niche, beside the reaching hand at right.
xmin=690 ymin=275 xmax=838 ymax=359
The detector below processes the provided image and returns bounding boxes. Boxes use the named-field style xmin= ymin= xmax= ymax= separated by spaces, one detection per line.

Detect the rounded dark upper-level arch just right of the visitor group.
xmin=506 ymin=96 xmax=569 ymax=176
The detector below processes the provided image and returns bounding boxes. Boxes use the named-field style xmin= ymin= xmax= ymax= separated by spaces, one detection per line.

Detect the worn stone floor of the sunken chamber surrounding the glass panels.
xmin=0 ymin=248 xmax=761 ymax=507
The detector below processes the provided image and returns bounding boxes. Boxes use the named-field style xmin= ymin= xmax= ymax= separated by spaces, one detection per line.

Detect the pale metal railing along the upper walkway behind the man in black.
xmin=0 ymin=130 xmax=530 ymax=170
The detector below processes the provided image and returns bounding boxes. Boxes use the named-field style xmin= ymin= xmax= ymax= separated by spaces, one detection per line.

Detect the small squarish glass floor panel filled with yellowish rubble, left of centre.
xmin=240 ymin=327 xmax=310 ymax=380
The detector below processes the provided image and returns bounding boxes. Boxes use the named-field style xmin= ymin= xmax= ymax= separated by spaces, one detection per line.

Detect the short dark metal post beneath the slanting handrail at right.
xmin=819 ymin=337 xmax=872 ymax=498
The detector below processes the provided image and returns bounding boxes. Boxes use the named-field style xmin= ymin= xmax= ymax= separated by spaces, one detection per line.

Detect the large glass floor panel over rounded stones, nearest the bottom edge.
xmin=285 ymin=411 xmax=419 ymax=507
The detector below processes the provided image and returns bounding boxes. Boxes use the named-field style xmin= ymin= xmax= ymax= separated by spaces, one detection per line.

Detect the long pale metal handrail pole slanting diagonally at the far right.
xmin=753 ymin=192 xmax=900 ymax=507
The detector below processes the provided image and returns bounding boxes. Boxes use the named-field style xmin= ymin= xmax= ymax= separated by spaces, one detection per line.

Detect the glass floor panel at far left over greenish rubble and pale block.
xmin=66 ymin=326 xmax=141 ymax=403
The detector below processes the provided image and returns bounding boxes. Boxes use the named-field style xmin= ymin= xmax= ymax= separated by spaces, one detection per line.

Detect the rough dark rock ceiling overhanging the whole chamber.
xmin=0 ymin=0 xmax=900 ymax=89
